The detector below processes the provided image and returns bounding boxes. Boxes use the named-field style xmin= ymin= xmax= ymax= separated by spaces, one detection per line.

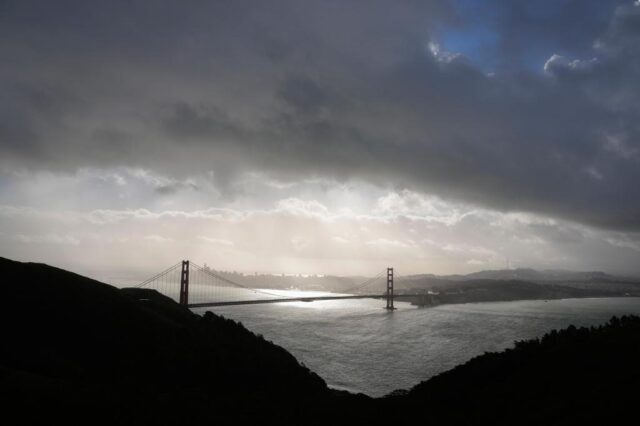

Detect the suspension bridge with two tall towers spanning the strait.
xmin=136 ymin=260 xmax=423 ymax=310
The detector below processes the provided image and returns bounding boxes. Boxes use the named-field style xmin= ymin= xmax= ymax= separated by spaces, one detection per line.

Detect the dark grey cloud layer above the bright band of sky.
xmin=0 ymin=0 xmax=640 ymax=231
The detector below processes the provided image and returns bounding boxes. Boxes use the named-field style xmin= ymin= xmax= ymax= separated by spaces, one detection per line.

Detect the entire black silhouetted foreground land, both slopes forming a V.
xmin=0 ymin=258 xmax=640 ymax=425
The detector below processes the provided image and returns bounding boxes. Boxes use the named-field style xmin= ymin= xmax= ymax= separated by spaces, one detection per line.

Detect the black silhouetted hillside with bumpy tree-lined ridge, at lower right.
xmin=384 ymin=316 xmax=640 ymax=425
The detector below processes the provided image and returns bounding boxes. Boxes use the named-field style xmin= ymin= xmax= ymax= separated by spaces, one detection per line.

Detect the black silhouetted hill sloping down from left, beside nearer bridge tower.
xmin=0 ymin=258 xmax=350 ymax=424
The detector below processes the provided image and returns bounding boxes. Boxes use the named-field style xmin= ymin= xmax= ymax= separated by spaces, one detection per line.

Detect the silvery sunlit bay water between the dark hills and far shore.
xmin=195 ymin=293 xmax=640 ymax=396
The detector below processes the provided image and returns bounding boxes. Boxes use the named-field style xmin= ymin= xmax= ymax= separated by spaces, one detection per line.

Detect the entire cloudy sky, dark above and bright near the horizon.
xmin=0 ymin=0 xmax=640 ymax=281
